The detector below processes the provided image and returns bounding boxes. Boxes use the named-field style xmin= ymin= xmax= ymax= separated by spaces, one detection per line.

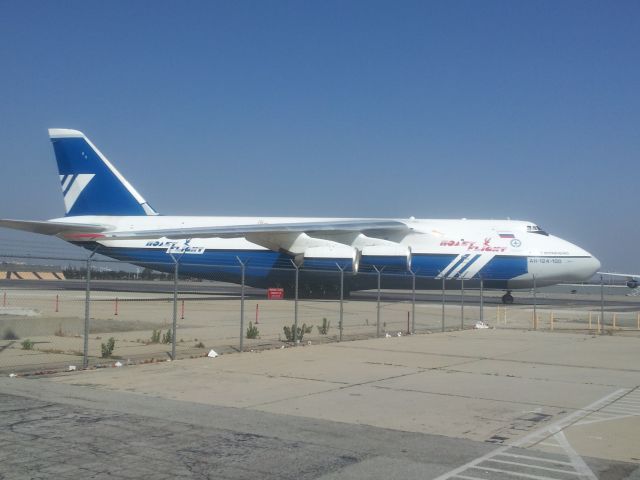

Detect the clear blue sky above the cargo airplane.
xmin=0 ymin=0 xmax=640 ymax=272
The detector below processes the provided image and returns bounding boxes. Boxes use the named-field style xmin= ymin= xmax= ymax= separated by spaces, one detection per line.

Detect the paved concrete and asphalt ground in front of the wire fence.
xmin=0 ymin=329 xmax=640 ymax=480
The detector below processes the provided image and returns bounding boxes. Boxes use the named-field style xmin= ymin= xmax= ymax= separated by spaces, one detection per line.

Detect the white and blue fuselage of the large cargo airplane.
xmin=52 ymin=216 xmax=599 ymax=290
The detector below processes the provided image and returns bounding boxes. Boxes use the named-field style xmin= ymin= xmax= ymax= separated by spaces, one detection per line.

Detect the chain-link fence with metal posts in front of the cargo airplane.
xmin=0 ymin=251 xmax=640 ymax=372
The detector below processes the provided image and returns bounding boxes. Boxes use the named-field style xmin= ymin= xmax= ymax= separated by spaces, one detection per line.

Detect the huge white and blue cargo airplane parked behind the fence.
xmin=0 ymin=129 xmax=600 ymax=303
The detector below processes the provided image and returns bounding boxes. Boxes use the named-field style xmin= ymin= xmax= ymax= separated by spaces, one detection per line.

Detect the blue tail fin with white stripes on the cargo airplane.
xmin=49 ymin=128 xmax=158 ymax=217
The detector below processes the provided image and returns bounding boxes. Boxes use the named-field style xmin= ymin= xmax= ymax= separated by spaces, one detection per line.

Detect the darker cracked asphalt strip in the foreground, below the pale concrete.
xmin=0 ymin=380 xmax=638 ymax=480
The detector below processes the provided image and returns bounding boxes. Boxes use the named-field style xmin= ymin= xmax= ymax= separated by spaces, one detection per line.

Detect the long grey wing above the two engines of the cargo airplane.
xmin=104 ymin=219 xmax=411 ymax=240
